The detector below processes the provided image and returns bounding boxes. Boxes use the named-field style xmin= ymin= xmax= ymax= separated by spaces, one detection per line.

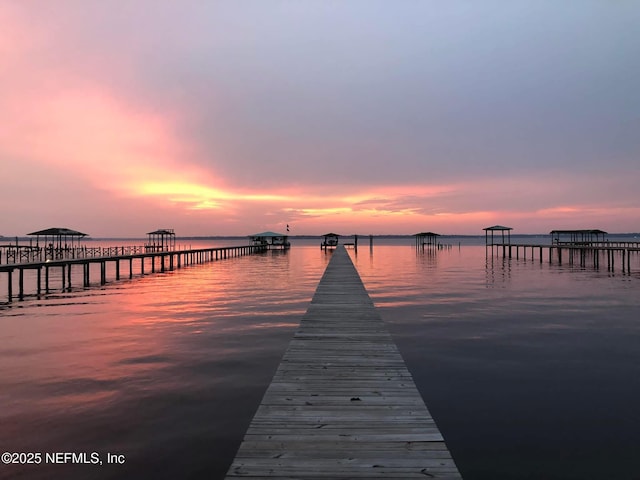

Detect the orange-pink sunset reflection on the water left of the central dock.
xmin=0 ymin=248 xmax=326 ymax=477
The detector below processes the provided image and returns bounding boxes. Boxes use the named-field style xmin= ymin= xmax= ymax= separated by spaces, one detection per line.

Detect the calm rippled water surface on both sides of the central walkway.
xmin=0 ymin=240 xmax=640 ymax=479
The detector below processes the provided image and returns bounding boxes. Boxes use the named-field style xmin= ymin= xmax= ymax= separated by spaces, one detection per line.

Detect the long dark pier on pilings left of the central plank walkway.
xmin=0 ymin=245 xmax=266 ymax=302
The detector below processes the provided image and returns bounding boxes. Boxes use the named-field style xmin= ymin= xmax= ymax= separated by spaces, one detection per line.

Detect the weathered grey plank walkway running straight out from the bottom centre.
xmin=226 ymin=246 xmax=461 ymax=479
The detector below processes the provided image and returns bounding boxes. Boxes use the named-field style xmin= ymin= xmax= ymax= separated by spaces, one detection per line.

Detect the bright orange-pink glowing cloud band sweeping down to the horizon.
xmin=0 ymin=64 xmax=638 ymax=233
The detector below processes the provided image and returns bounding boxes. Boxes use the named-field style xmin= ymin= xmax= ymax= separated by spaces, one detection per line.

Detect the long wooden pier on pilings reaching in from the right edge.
xmin=486 ymin=242 xmax=640 ymax=273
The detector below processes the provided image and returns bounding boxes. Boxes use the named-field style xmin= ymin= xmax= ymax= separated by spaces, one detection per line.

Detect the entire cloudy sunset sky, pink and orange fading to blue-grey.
xmin=0 ymin=0 xmax=640 ymax=237
